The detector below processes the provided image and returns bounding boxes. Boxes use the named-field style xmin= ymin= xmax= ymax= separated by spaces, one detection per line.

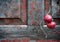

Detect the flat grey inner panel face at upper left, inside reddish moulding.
xmin=0 ymin=0 xmax=20 ymax=18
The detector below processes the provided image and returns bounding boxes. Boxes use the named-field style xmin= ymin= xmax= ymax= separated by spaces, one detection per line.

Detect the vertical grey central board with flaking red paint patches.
xmin=28 ymin=0 xmax=44 ymax=25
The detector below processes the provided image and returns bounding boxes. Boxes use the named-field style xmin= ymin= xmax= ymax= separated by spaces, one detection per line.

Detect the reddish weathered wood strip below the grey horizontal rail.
xmin=0 ymin=39 xmax=60 ymax=42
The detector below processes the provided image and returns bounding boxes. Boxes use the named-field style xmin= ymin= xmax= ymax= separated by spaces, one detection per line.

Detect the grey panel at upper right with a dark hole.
xmin=51 ymin=0 xmax=60 ymax=18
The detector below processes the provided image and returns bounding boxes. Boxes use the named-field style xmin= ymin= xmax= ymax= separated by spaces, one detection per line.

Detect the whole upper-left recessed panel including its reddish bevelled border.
xmin=0 ymin=0 xmax=27 ymax=25
